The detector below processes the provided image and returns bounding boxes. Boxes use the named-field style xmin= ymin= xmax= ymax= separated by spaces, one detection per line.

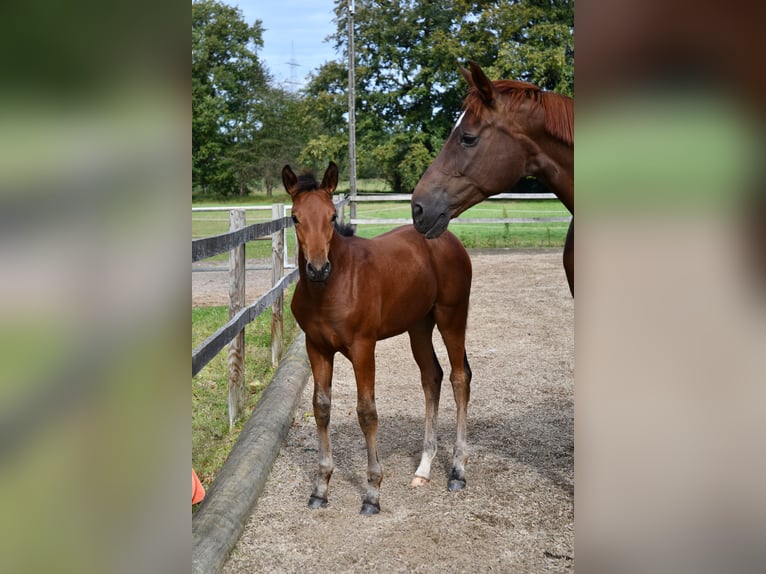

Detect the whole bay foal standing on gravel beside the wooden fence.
xmin=282 ymin=162 xmax=471 ymax=514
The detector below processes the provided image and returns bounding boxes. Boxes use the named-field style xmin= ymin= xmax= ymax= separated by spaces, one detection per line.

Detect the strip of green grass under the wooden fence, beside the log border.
xmin=192 ymin=289 xmax=298 ymax=488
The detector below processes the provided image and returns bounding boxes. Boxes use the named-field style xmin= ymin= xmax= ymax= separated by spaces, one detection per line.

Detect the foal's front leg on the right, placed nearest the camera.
xmin=350 ymin=340 xmax=383 ymax=514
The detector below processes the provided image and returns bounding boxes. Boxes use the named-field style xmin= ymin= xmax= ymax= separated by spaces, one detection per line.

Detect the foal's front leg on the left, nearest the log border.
xmin=306 ymin=340 xmax=334 ymax=508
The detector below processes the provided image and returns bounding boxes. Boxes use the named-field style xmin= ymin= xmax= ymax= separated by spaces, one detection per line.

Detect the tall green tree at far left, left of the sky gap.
xmin=192 ymin=0 xmax=268 ymax=194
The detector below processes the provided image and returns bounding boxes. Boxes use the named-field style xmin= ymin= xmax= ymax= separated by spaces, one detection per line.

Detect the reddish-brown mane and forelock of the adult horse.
xmin=463 ymin=80 xmax=574 ymax=146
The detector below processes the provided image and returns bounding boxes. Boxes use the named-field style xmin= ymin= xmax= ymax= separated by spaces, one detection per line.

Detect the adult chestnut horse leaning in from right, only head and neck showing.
xmin=412 ymin=62 xmax=574 ymax=296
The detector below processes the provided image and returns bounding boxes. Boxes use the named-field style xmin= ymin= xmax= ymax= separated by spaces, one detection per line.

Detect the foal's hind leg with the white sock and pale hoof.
xmin=409 ymin=314 xmax=444 ymax=486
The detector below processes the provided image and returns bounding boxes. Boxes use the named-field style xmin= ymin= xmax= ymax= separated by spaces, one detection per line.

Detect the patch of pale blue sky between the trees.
xmin=230 ymin=0 xmax=343 ymax=90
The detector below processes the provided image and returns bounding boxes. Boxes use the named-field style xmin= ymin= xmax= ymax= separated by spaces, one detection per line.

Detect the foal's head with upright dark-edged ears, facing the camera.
xmin=282 ymin=162 xmax=338 ymax=281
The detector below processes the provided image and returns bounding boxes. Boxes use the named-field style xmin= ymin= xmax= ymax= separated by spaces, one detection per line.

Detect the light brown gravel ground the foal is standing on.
xmin=207 ymin=250 xmax=574 ymax=574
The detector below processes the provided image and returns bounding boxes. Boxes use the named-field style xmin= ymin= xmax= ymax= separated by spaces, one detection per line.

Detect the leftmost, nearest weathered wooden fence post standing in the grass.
xmin=229 ymin=209 xmax=247 ymax=430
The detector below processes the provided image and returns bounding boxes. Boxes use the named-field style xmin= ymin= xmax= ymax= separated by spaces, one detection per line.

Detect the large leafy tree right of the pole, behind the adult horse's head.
xmin=333 ymin=0 xmax=574 ymax=191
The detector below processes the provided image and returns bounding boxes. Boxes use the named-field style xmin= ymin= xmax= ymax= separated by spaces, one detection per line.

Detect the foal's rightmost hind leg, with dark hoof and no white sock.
xmin=436 ymin=308 xmax=471 ymax=490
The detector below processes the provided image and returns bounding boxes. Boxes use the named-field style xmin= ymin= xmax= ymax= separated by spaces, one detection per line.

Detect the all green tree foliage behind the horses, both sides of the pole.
xmin=192 ymin=0 xmax=574 ymax=198
